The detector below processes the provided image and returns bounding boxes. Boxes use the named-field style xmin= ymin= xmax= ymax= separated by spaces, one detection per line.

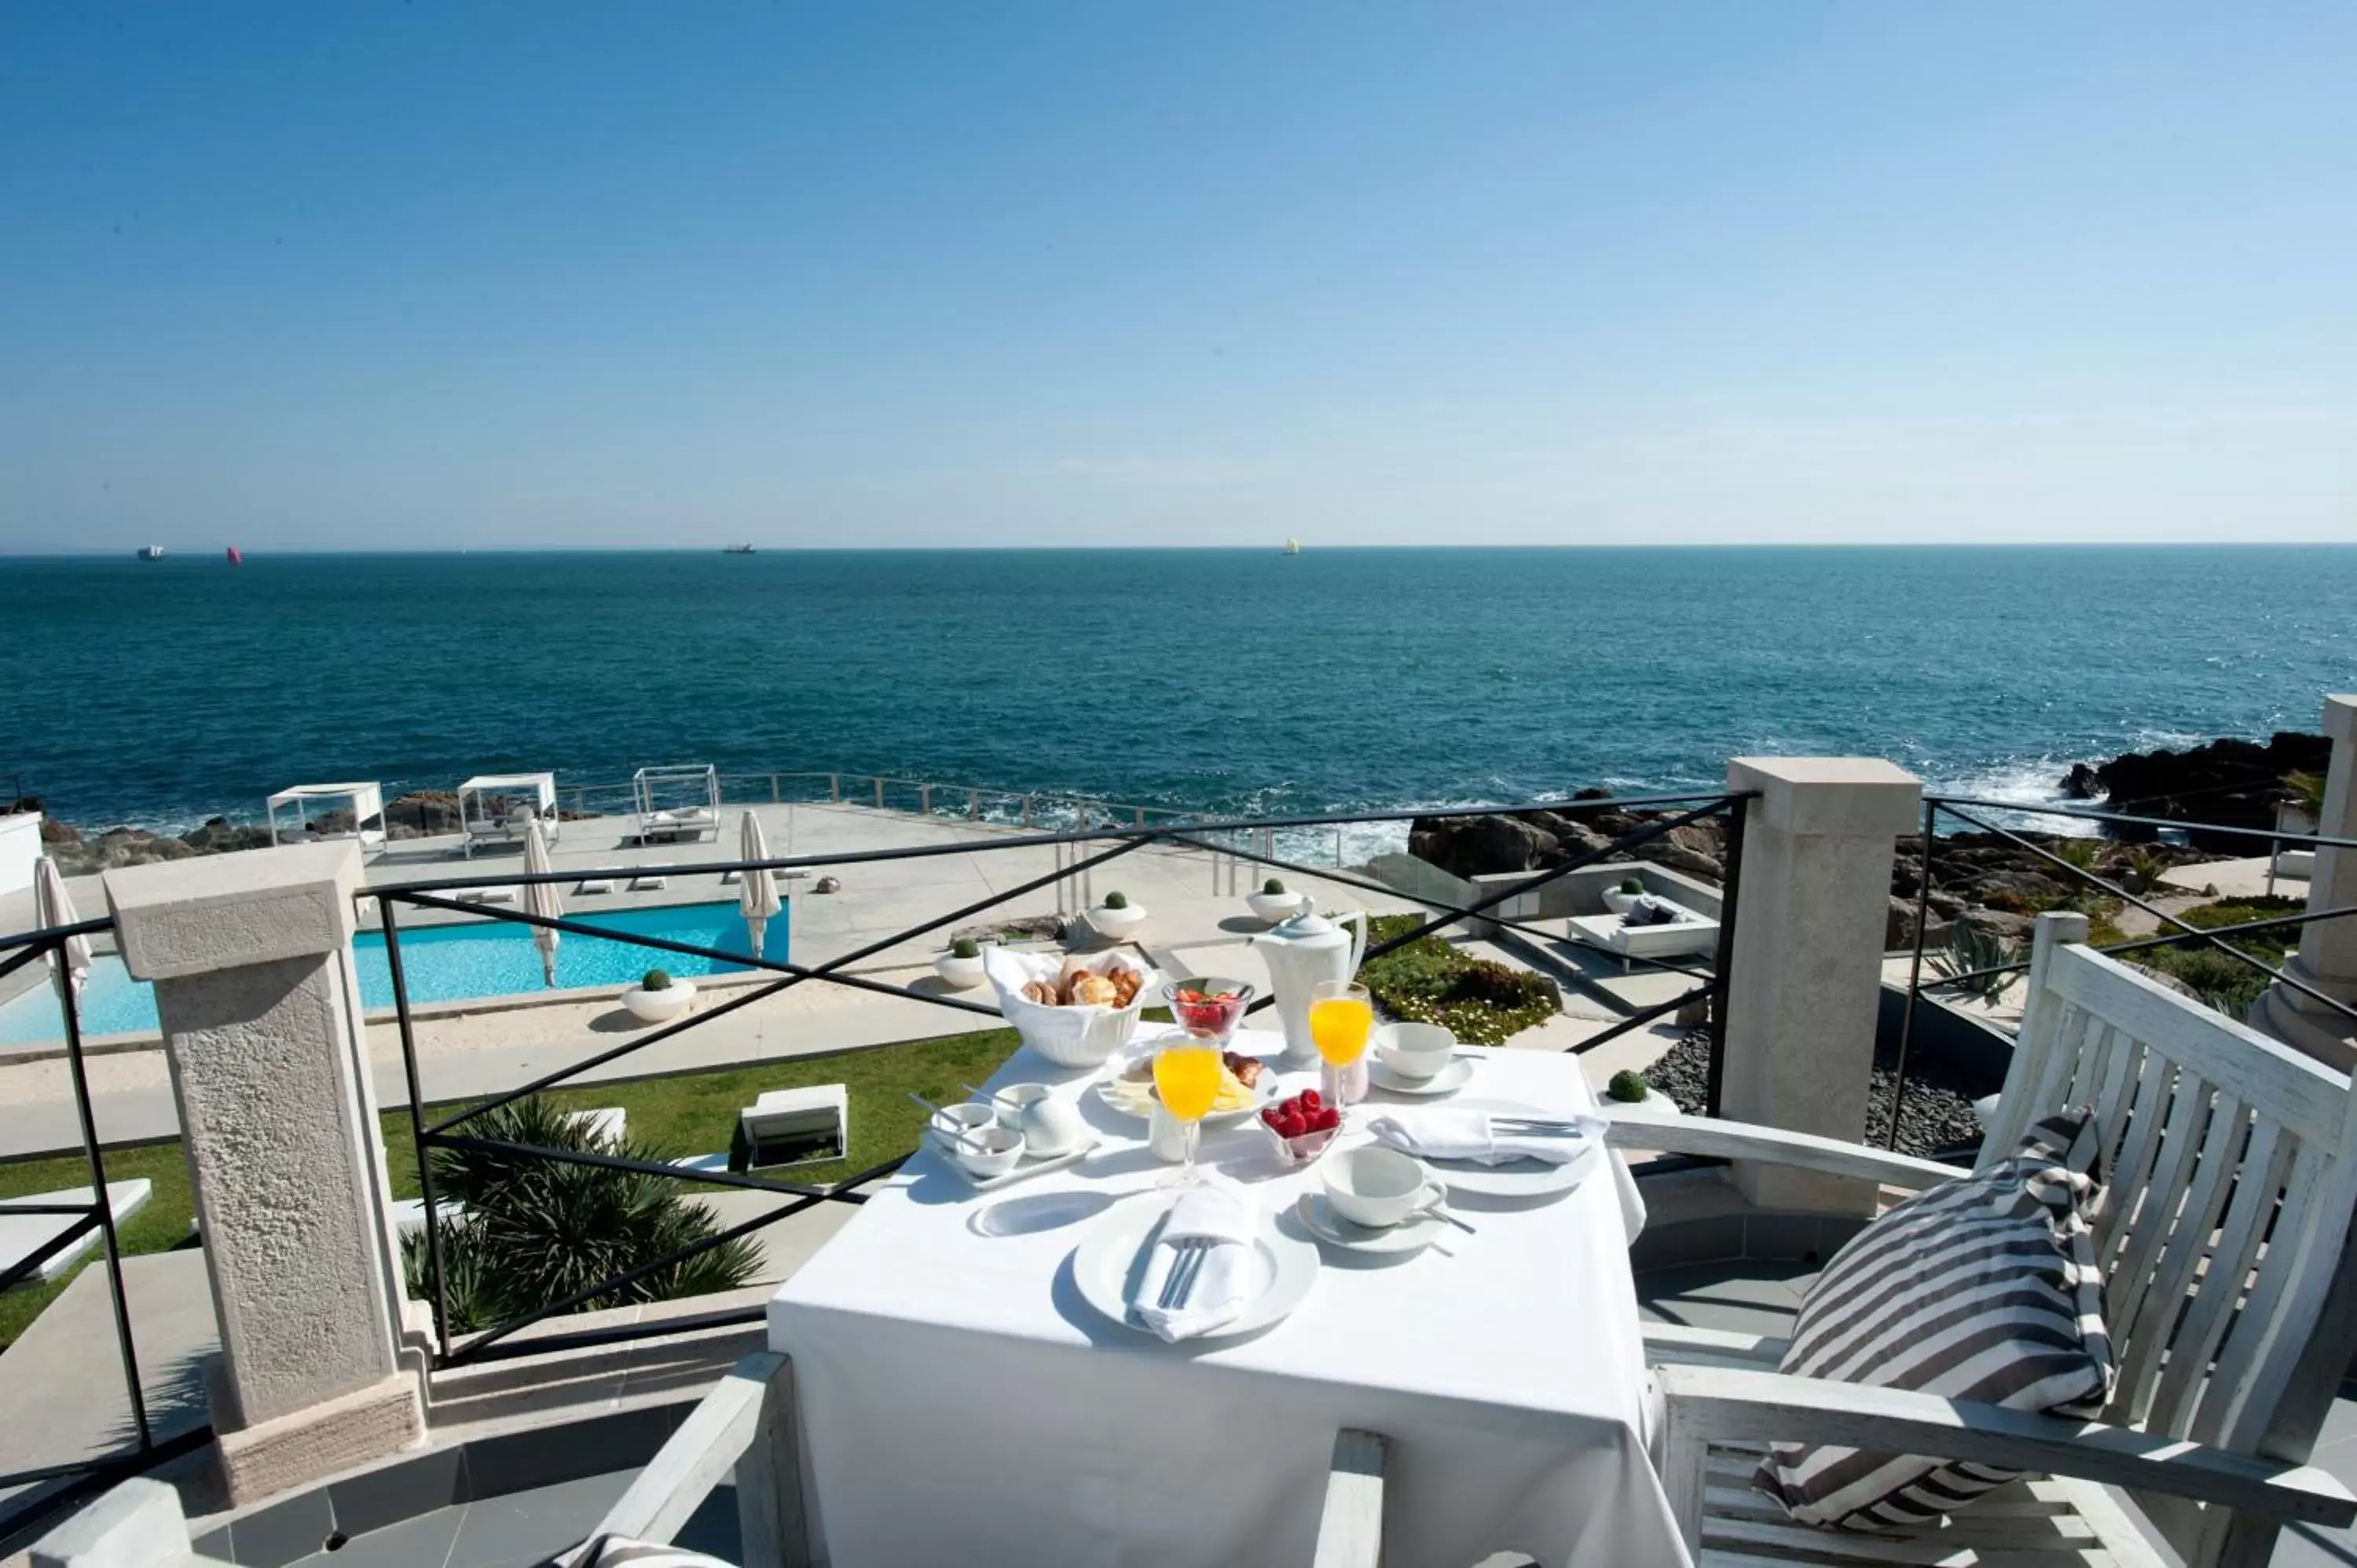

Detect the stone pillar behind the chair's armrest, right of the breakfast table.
xmin=1721 ymin=757 xmax=1923 ymax=1214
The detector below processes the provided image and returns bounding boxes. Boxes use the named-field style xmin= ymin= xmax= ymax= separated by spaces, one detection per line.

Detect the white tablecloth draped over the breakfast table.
xmin=768 ymin=1026 xmax=1688 ymax=1568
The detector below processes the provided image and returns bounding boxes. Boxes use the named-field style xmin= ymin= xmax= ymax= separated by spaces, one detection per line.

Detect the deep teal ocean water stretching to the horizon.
xmin=0 ymin=547 xmax=2357 ymax=826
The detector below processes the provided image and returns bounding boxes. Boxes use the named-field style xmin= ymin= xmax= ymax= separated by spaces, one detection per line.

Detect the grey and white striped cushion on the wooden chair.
xmin=1754 ymin=1111 xmax=2114 ymax=1530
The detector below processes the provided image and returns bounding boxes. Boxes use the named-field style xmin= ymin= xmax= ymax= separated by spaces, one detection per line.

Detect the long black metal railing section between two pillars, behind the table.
xmin=377 ymin=795 xmax=1749 ymax=1368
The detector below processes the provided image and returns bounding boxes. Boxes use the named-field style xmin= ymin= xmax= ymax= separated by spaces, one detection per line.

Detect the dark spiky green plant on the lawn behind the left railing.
xmin=401 ymin=1094 xmax=761 ymax=1332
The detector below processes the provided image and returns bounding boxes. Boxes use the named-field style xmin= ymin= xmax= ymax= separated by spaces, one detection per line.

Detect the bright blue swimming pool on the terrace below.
xmin=0 ymin=903 xmax=787 ymax=1045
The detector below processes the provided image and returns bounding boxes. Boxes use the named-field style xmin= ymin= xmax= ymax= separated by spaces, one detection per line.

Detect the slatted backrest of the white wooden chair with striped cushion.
xmin=1985 ymin=915 xmax=2357 ymax=1561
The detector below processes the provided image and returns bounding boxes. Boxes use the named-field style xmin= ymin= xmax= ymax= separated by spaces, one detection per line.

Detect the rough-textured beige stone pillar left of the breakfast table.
xmin=106 ymin=842 xmax=424 ymax=1502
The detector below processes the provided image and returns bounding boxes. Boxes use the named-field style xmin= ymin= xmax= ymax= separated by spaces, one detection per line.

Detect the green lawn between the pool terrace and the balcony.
xmin=0 ymin=1028 xmax=1018 ymax=1346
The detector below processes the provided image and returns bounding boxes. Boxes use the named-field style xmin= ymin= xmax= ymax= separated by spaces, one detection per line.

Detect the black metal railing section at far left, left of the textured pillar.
xmin=0 ymin=920 xmax=212 ymax=1540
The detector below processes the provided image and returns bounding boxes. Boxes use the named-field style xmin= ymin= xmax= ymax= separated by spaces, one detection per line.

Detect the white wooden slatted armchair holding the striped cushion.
xmin=1612 ymin=915 xmax=2357 ymax=1568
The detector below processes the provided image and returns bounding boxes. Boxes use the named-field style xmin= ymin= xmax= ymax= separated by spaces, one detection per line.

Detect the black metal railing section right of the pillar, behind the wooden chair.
xmin=1888 ymin=795 xmax=2357 ymax=1146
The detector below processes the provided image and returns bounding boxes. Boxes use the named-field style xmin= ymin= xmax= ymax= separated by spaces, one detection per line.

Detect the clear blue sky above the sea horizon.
xmin=0 ymin=0 xmax=2357 ymax=549
